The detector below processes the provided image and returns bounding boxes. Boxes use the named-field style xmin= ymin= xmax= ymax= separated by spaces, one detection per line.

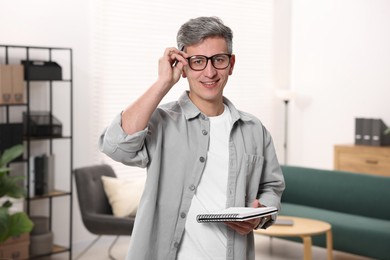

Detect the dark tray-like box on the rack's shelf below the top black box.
xmin=23 ymin=111 xmax=62 ymax=136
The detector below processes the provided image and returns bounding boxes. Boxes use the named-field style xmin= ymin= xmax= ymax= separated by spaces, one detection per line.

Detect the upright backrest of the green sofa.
xmin=282 ymin=166 xmax=390 ymax=220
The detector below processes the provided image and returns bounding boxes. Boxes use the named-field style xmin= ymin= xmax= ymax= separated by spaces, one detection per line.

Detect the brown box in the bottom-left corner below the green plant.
xmin=0 ymin=233 xmax=30 ymax=260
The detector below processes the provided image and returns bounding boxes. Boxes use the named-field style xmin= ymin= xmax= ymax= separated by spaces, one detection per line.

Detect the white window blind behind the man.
xmin=91 ymin=0 xmax=273 ymax=175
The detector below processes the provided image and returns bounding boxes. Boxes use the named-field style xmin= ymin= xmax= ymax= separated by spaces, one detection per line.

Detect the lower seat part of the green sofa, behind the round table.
xmin=280 ymin=202 xmax=390 ymax=259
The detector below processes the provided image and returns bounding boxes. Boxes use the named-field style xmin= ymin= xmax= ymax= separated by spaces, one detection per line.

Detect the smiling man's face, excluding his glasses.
xmin=183 ymin=37 xmax=235 ymax=106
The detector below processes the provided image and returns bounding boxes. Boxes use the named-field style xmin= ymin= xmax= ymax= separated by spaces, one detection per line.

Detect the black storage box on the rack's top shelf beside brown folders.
xmin=22 ymin=60 xmax=62 ymax=80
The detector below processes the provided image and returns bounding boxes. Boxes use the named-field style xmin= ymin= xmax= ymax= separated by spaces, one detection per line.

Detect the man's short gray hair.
xmin=176 ymin=17 xmax=233 ymax=54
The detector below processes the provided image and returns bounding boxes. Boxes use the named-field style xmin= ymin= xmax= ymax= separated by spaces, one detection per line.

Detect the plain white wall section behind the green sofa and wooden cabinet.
xmin=289 ymin=0 xmax=390 ymax=168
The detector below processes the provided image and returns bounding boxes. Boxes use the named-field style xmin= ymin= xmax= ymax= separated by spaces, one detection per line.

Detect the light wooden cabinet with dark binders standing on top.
xmin=334 ymin=145 xmax=390 ymax=177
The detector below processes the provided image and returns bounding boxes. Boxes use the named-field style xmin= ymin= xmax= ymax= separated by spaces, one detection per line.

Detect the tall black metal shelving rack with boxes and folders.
xmin=0 ymin=45 xmax=73 ymax=259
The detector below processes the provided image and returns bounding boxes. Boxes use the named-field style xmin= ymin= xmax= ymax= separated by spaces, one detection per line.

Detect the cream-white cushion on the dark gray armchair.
xmin=102 ymin=176 xmax=145 ymax=217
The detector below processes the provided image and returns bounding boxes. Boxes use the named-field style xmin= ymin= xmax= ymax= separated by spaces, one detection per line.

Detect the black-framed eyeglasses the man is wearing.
xmin=187 ymin=53 xmax=232 ymax=71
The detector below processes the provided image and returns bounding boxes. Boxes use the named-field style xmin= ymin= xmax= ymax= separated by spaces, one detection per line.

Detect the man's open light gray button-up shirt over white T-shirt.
xmin=99 ymin=92 xmax=284 ymax=260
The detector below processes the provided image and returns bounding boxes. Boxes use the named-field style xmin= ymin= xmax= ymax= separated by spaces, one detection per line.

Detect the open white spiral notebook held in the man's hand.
xmin=196 ymin=207 xmax=278 ymax=223
